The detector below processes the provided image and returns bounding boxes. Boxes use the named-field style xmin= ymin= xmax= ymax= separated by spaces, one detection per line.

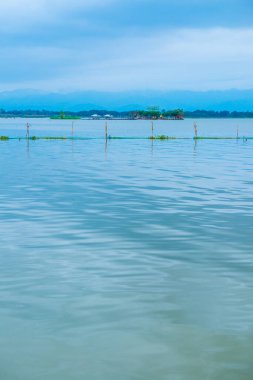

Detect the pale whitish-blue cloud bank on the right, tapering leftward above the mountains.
xmin=67 ymin=28 xmax=253 ymax=90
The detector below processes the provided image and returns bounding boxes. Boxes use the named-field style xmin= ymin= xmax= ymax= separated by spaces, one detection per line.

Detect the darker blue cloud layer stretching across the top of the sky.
xmin=0 ymin=0 xmax=253 ymax=37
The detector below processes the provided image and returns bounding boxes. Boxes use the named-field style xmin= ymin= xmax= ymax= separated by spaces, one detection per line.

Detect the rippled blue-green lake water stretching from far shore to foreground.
xmin=0 ymin=119 xmax=253 ymax=380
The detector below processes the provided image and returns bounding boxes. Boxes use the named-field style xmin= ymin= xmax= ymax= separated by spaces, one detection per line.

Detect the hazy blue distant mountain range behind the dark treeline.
xmin=0 ymin=90 xmax=253 ymax=112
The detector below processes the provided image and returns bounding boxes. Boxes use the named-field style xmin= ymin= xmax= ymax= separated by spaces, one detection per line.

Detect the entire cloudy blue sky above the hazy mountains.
xmin=0 ymin=0 xmax=253 ymax=91
